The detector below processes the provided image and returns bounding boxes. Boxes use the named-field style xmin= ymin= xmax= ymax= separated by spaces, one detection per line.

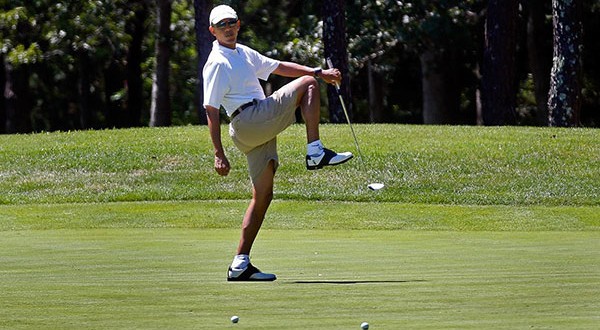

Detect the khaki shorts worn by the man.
xmin=229 ymin=81 xmax=297 ymax=183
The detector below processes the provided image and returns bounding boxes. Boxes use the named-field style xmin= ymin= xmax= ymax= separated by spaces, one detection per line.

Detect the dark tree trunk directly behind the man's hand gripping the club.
xmin=322 ymin=0 xmax=352 ymax=123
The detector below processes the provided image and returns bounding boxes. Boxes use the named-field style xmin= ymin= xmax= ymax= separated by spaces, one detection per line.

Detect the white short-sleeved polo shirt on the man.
xmin=202 ymin=40 xmax=280 ymax=116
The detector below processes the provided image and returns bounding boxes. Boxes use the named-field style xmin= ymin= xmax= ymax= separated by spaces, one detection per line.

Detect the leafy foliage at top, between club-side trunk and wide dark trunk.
xmin=348 ymin=0 xmax=482 ymax=67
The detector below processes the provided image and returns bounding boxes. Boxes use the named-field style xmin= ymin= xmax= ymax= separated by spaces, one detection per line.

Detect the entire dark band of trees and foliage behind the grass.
xmin=0 ymin=0 xmax=600 ymax=133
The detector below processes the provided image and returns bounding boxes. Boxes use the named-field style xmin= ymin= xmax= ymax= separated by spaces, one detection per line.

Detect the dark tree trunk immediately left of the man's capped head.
xmin=194 ymin=0 xmax=214 ymax=125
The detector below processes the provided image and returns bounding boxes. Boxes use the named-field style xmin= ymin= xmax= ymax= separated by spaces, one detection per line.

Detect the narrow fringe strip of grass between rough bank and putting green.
xmin=0 ymin=200 xmax=600 ymax=233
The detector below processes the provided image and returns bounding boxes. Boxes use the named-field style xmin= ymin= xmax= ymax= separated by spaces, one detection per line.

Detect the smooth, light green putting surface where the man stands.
xmin=0 ymin=228 xmax=600 ymax=329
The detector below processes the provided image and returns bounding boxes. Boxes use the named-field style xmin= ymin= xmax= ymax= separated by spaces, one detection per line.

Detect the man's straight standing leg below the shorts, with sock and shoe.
xmin=227 ymin=160 xmax=277 ymax=281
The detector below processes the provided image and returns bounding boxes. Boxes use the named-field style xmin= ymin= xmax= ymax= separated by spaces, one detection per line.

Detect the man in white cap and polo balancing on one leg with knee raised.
xmin=202 ymin=5 xmax=353 ymax=281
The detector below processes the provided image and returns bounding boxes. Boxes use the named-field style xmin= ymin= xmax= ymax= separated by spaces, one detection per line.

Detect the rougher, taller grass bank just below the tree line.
xmin=0 ymin=125 xmax=600 ymax=206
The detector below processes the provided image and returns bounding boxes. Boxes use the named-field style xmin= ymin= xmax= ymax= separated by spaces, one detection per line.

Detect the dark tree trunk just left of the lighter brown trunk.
xmin=125 ymin=0 xmax=149 ymax=127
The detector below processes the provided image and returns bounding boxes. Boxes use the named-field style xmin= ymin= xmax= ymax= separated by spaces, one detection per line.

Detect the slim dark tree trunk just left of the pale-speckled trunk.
xmin=525 ymin=0 xmax=552 ymax=126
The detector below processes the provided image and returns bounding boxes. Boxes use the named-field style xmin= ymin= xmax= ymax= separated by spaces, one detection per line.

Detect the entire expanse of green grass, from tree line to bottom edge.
xmin=0 ymin=125 xmax=600 ymax=329
